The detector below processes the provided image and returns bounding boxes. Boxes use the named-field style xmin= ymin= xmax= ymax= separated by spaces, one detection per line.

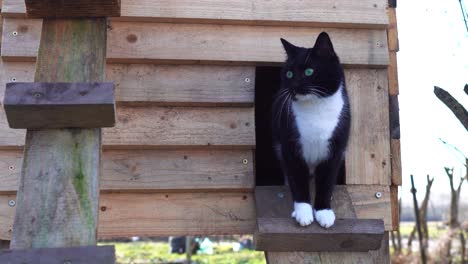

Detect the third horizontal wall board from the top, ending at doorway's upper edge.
xmin=0 ymin=61 xmax=255 ymax=106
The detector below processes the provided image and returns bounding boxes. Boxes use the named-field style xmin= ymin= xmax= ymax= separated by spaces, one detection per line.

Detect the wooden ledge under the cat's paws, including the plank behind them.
xmin=254 ymin=186 xmax=385 ymax=252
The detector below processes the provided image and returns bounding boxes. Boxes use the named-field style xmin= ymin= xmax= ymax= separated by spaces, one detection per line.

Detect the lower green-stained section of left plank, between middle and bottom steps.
xmin=11 ymin=129 xmax=100 ymax=249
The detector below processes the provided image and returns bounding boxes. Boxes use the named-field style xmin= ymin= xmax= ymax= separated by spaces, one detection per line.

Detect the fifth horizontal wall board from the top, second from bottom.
xmin=0 ymin=149 xmax=255 ymax=193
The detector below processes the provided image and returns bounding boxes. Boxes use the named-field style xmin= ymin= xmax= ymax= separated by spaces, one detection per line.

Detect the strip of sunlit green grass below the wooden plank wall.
xmin=101 ymin=242 xmax=266 ymax=264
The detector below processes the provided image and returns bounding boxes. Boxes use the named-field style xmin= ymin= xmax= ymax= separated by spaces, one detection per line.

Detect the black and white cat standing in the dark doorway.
xmin=272 ymin=32 xmax=351 ymax=228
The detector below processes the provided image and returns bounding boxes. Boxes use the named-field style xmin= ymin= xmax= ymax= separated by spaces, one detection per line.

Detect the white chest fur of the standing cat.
xmin=292 ymin=87 xmax=344 ymax=173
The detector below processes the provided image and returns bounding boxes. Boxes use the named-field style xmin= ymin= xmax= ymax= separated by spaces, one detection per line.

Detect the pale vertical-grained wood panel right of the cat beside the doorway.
xmin=346 ymin=69 xmax=391 ymax=185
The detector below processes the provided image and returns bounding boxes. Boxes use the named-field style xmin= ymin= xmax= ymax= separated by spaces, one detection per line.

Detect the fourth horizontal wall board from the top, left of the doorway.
xmin=0 ymin=106 xmax=255 ymax=149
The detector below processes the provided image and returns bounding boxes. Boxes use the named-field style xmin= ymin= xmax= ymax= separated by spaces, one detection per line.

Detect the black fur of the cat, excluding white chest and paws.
xmin=272 ymin=32 xmax=351 ymax=226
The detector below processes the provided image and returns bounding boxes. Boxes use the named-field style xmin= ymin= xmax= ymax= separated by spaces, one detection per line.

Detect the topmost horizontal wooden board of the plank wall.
xmin=2 ymin=0 xmax=388 ymax=28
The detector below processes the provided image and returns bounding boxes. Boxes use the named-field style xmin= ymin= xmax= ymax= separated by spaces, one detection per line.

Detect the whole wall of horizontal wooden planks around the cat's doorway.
xmin=0 ymin=0 xmax=394 ymax=239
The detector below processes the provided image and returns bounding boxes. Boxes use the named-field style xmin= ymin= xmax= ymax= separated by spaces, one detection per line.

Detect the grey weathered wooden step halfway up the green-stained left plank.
xmin=3 ymin=82 xmax=115 ymax=129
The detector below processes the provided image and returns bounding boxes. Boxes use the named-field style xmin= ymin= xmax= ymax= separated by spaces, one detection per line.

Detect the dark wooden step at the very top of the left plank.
xmin=25 ymin=0 xmax=120 ymax=18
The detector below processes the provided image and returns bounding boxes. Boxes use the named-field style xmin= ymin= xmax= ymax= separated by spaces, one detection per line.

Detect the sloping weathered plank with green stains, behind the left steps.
xmin=11 ymin=19 xmax=107 ymax=249
